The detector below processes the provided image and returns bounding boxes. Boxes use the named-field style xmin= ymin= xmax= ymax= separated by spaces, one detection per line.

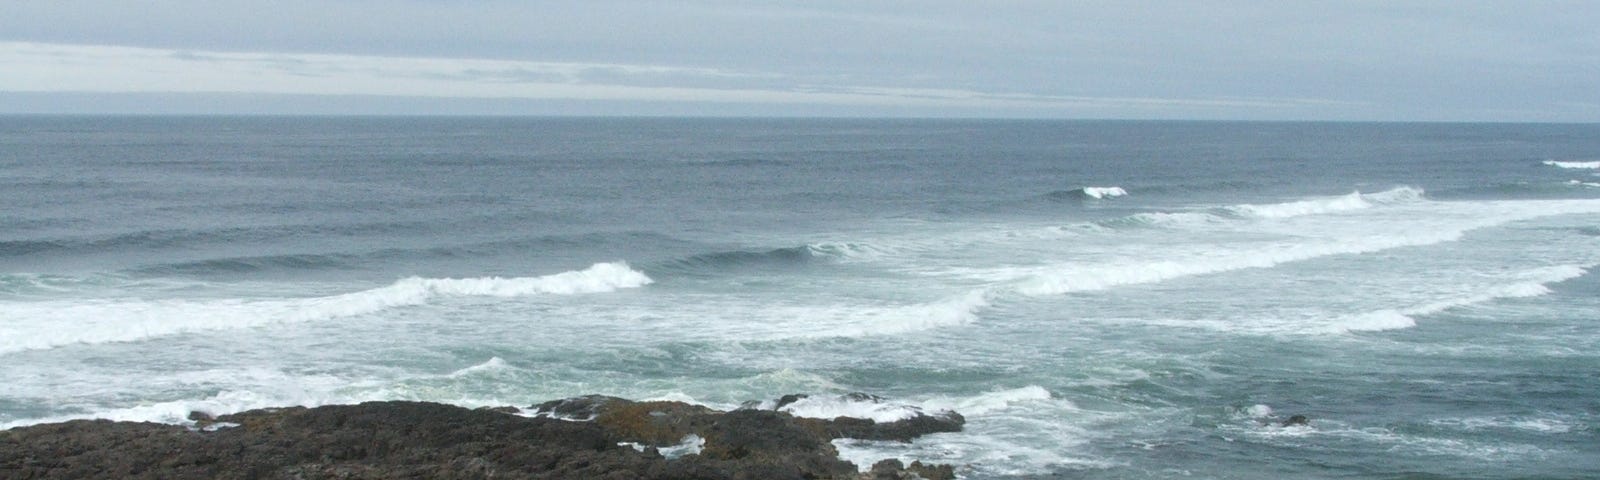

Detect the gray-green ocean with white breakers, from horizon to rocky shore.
xmin=0 ymin=117 xmax=1600 ymax=478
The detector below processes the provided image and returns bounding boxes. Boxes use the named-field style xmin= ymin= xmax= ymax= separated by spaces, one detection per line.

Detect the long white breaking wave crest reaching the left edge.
xmin=0 ymin=262 xmax=653 ymax=354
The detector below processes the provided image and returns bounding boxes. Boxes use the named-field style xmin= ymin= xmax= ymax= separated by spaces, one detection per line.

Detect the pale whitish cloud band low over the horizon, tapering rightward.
xmin=0 ymin=42 xmax=1363 ymax=112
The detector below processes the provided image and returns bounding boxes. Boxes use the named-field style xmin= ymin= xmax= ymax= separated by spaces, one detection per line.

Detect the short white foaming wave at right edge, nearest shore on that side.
xmin=1318 ymin=266 xmax=1594 ymax=333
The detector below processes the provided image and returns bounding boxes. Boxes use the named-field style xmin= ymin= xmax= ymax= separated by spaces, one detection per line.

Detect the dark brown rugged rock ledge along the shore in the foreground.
xmin=0 ymin=397 xmax=965 ymax=480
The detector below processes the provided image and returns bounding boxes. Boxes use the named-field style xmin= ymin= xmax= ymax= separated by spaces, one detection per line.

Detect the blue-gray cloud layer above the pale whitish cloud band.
xmin=0 ymin=0 xmax=1600 ymax=122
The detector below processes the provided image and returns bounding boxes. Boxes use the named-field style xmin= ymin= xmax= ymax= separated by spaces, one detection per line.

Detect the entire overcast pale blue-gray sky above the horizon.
xmin=0 ymin=0 xmax=1600 ymax=122
